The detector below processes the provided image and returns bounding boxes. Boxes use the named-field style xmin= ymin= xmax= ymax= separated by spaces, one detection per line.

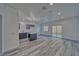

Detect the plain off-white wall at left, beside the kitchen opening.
xmin=0 ymin=4 xmax=19 ymax=53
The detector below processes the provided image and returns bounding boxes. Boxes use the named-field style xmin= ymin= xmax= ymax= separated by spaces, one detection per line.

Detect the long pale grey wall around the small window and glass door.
xmin=41 ymin=17 xmax=79 ymax=41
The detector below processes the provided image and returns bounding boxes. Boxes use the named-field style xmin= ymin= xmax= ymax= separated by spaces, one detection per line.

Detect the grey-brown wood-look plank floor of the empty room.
xmin=3 ymin=39 xmax=79 ymax=56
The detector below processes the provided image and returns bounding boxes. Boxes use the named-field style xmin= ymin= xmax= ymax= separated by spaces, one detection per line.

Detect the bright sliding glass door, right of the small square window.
xmin=52 ymin=25 xmax=62 ymax=38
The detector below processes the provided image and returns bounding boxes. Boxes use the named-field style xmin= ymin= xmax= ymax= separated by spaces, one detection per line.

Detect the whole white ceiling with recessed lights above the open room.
xmin=7 ymin=3 xmax=79 ymax=23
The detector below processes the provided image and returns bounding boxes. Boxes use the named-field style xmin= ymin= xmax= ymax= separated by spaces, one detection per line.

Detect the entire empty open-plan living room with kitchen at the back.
xmin=0 ymin=3 xmax=79 ymax=56
